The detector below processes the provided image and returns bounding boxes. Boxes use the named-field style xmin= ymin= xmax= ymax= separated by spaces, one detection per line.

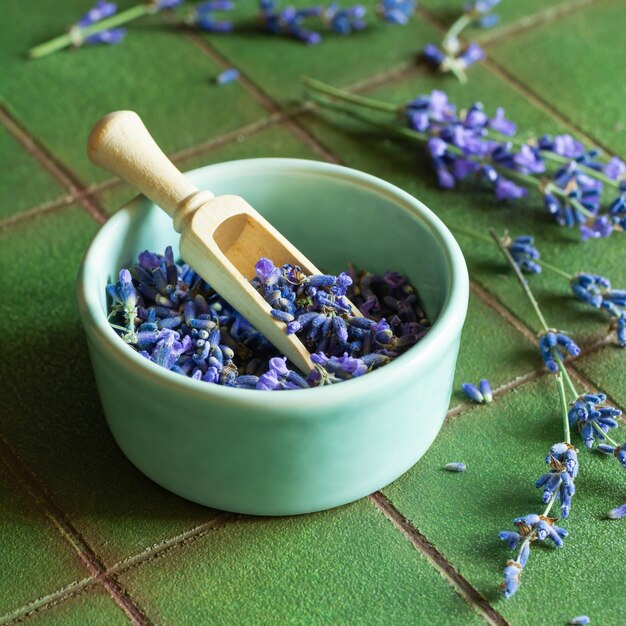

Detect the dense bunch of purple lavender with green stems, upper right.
xmin=304 ymin=78 xmax=626 ymax=240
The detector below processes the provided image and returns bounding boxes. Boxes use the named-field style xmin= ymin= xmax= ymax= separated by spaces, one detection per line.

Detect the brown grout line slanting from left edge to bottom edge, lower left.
xmin=0 ymin=434 xmax=152 ymax=626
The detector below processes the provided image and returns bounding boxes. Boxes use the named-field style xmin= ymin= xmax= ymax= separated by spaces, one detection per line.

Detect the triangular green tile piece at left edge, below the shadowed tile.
xmin=0 ymin=457 xmax=87 ymax=616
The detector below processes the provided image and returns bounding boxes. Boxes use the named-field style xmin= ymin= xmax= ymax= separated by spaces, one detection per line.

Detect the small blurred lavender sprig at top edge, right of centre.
xmin=423 ymin=0 xmax=500 ymax=83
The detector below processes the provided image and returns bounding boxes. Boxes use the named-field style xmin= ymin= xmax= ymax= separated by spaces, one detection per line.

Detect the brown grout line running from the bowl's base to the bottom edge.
xmin=368 ymin=491 xmax=508 ymax=626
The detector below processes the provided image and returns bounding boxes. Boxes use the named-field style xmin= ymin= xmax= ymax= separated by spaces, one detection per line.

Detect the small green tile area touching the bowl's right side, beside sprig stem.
xmin=451 ymin=294 xmax=538 ymax=405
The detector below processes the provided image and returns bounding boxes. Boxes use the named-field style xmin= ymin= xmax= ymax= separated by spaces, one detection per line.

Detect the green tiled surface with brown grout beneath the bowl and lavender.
xmin=0 ymin=0 xmax=626 ymax=625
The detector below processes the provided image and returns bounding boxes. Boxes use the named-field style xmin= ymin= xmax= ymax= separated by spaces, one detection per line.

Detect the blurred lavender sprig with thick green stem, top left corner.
xmin=28 ymin=0 xmax=183 ymax=59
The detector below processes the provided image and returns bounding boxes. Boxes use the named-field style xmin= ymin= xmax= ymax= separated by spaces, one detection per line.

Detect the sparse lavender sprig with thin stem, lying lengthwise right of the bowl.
xmin=490 ymin=230 xmax=626 ymax=598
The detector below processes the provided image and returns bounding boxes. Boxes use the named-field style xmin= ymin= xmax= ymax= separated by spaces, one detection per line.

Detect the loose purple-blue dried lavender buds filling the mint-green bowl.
xmin=107 ymin=247 xmax=430 ymax=390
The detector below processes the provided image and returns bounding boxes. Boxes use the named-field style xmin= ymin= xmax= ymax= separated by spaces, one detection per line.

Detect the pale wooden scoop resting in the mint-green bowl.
xmin=88 ymin=111 xmax=361 ymax=372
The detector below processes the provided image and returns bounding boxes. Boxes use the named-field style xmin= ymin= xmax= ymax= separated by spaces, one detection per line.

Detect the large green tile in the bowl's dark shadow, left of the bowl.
xmin=0 ymin=208 xmax=215 ymax=564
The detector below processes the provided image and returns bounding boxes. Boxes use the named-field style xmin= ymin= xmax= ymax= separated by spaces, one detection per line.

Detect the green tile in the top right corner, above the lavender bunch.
xmin=490 ymin=0 xmax=626 ymax=156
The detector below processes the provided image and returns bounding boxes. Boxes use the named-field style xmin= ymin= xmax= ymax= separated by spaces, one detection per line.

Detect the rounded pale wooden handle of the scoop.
xmin=87 ymin=111 xmax=214 ymax=232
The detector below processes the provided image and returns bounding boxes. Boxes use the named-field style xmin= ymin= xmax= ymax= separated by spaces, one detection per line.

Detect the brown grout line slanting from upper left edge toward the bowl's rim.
xmin=0 ymin=105 xmax=106 ymax=224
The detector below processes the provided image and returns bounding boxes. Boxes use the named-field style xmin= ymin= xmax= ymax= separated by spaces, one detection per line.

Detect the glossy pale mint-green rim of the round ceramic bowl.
xmin=77 ymin=157 xmax=469 ymax=411
